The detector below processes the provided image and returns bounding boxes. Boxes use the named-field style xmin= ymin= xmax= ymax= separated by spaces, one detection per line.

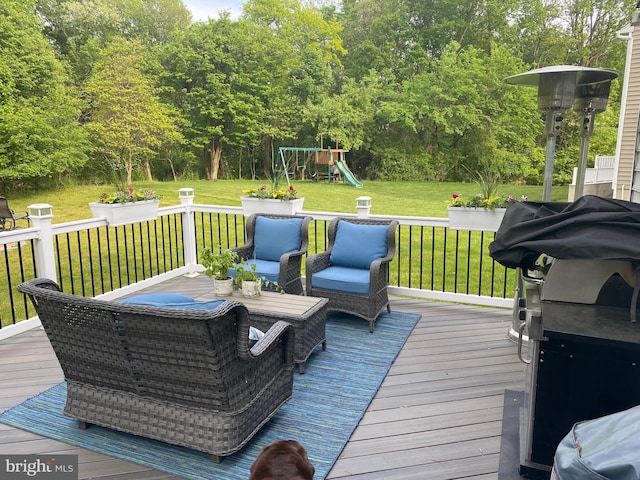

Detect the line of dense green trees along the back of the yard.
xmin=0 ymin=0 xmax=635 ymax=191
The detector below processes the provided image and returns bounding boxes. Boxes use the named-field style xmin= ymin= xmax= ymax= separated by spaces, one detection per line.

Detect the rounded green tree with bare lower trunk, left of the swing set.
xmin=160 ymin=17 xmax=266 ymax=180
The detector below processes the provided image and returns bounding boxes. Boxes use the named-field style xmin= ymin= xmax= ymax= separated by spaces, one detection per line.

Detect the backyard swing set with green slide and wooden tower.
xmin=273 ymin=147 xmax=363 ymax=188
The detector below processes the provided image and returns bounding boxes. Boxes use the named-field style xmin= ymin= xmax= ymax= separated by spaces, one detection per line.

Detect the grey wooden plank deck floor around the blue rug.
xmin=0 ymin=286 xmax=525 ymax=480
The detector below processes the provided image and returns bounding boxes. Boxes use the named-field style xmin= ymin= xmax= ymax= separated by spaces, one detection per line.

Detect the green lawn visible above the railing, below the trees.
xmin=9 ymin=180 xmax=568 ymax=223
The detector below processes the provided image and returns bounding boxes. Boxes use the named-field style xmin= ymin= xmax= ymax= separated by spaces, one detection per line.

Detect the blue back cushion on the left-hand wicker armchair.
xmin=253 ymin=217 xmax=302 ymax=262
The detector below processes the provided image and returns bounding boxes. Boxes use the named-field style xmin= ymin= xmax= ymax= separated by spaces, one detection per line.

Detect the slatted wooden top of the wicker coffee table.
xmin=196 ymin=289 xmax=329 ymax=317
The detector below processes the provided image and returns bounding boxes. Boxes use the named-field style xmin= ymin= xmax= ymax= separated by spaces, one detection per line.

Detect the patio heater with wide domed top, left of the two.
xmin=505 ymin=65 xmax=618 ymax=202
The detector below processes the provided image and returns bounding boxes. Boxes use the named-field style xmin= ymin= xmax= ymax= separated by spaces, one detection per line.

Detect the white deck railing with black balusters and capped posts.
xmin=0 ymin=189 xmax=515 ymax=339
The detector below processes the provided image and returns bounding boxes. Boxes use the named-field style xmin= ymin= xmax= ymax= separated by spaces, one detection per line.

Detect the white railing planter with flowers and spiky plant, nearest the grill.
xmin=447 ymin=173 xmax=527 ymax=232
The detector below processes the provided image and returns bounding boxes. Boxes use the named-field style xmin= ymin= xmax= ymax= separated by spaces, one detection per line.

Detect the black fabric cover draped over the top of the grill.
xmin=489 ymin=195 xmax=640 ymax=270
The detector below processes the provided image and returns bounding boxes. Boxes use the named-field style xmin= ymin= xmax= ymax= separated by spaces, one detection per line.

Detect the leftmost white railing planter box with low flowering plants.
xmin=89 ymin=187 xmax=162 ymax=227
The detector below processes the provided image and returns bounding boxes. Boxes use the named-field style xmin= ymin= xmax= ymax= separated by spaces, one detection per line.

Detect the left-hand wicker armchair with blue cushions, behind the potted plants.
xmin=232 ymin=213 xmax=311 ymax=295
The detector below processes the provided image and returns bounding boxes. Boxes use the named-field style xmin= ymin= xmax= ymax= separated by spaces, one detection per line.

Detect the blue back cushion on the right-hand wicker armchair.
xmin=329 ymin=220 xmax=389 ymax=269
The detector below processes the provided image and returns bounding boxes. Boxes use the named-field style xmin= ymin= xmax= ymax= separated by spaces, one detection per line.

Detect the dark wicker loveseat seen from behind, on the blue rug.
xmin=18 ymin=279 xmax=294 ymax=462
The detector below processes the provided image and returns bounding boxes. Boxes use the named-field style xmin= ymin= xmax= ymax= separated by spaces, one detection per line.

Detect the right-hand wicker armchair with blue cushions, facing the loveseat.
xmin=306 ymin=217 xmax=398 ymax=332
